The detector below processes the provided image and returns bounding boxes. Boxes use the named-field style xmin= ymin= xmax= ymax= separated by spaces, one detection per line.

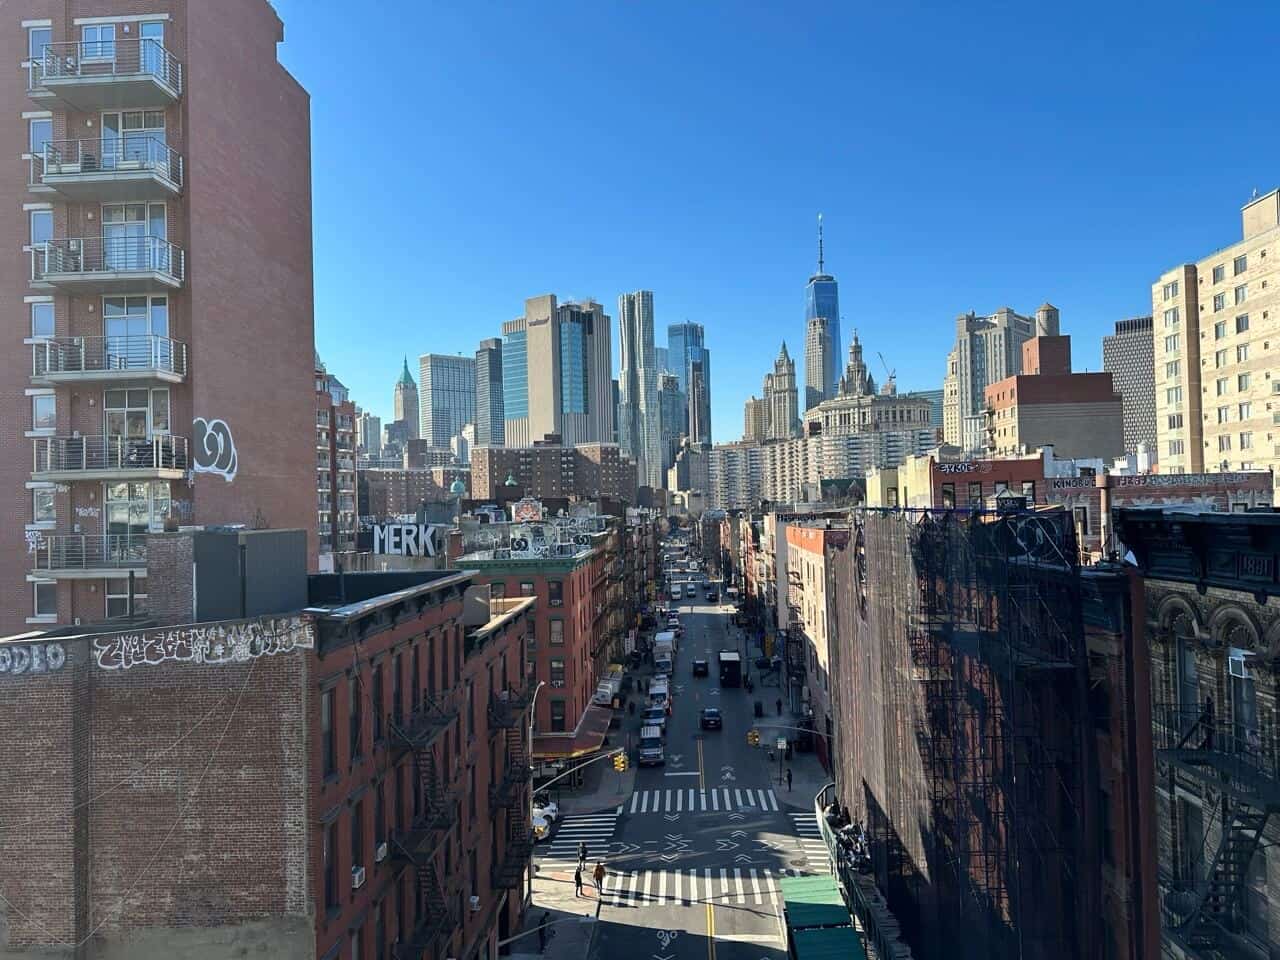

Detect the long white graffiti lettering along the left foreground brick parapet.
xmin=93 ymin=617 xmax=315 ymax=669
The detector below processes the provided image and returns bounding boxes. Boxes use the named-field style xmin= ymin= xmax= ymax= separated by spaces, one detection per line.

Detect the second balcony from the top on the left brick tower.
xmin=27 ymin=134 xmax=183 ymax=202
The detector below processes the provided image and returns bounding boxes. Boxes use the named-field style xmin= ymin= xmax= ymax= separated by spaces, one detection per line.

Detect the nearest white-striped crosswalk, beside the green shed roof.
xmin=604 ymin=867 xmax=781 ymax=908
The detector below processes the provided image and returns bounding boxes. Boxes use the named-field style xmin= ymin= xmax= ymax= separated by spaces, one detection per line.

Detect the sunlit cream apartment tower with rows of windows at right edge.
xmin=1151 ymin=191 xmax=1280 ymax=488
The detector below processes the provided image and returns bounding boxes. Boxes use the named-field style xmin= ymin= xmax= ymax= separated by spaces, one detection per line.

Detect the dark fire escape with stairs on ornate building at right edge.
xmin=1153 ymin=704 xmax=1280 ymax=955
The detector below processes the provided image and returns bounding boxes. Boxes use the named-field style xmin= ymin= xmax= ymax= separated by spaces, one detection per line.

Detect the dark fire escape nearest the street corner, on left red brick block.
xmin=489 ymin=685 xmax=534 ymax=890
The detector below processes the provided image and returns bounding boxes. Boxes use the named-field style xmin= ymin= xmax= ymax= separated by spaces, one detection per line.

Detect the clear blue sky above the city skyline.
xmin=275 ymin=0 xmax=1280 ymax=440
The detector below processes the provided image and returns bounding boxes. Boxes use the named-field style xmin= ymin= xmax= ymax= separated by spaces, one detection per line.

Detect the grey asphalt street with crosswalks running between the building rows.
xmin=540 ymin=599 xmax=827 ymax=960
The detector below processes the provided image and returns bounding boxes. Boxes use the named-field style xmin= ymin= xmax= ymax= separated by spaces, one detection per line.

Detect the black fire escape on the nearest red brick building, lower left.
xmin=388 ymin=692 xmax=461 ymax=960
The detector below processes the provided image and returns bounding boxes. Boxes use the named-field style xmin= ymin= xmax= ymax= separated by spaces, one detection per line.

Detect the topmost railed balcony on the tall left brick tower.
xmin=27 ymin=40 xmax=182 ymax=113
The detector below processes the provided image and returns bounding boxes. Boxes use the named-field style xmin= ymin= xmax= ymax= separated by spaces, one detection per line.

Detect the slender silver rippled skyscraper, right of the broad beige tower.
xmin=618 ymin=291 xmax=663 ymax=488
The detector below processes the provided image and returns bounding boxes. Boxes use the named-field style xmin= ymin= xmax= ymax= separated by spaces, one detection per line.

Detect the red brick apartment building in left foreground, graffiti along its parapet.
xmin=0 ymin=530 xmax=535 ymax=960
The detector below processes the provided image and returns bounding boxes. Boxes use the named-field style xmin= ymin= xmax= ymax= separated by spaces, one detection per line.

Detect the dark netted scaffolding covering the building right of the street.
xmin=854 ymin=509 xmax=1097 ymax=960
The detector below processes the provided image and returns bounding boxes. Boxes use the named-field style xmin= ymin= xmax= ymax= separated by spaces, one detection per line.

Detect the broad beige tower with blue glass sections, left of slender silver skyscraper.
xmin=502 ymin=293 xmax=613 ymax=447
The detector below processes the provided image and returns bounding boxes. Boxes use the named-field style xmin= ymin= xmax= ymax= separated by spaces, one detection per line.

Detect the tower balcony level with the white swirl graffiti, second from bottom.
xmin=31 ymin=435 xmax=189 ymax=483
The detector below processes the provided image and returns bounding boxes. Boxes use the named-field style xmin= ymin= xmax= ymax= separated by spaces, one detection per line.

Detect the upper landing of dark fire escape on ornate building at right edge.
xmin=1152 ymin=704 xmax=1280 ymax=813
